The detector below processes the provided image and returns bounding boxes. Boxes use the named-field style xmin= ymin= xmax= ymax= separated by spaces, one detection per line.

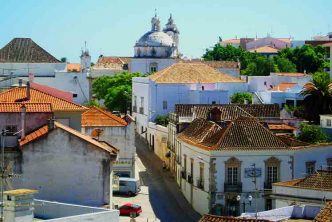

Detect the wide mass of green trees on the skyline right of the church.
xmin=203 ymin=44 xmax=329 ymax=76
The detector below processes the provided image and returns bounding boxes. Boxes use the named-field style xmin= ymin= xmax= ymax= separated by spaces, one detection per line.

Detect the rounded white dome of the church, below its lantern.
xmin=136 ymin=31 xmax=174 ymax=47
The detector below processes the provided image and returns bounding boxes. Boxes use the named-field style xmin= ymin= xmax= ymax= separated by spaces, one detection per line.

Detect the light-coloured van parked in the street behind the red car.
xmin=113 ymin=177 xmax=141 ymax=196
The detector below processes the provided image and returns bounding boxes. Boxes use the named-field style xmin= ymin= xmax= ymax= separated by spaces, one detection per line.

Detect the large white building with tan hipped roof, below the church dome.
xmin=132 ymin=63 xmax=247 ymax=138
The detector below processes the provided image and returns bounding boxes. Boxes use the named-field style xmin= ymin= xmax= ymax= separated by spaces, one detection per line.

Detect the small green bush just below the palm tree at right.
xmin=297 ymin=123 xmax=328 ymax=143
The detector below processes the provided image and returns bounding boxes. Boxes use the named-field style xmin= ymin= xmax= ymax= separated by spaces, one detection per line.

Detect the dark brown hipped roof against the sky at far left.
xmin=0 ymin=38 xmax=60 ymax=63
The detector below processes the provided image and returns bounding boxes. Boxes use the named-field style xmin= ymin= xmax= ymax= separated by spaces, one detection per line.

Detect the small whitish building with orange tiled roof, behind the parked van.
xmin=82 ymin=107 xmax=136 ymax=177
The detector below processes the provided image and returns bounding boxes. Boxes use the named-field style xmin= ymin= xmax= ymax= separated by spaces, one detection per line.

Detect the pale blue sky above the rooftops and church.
xmin=0 ymin=0 xmax=332 ymax=62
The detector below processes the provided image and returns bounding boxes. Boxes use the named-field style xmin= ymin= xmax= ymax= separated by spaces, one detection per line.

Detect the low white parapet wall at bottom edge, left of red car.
xmin=34 ymin=199 xmax=119 ymax=222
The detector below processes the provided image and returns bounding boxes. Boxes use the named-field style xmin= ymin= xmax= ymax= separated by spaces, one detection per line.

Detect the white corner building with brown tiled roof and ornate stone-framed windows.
xmin=175 ymin=115 xmax=332 ymax=215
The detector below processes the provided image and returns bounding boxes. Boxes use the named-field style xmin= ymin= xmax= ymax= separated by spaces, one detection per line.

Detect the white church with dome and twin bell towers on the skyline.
xmin=129 ymin=15 xmax=180 ymax=73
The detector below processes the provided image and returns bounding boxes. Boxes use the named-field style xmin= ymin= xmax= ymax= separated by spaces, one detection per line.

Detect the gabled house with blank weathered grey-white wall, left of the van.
xmin=13 ymin=121 xmax=118 ymax=206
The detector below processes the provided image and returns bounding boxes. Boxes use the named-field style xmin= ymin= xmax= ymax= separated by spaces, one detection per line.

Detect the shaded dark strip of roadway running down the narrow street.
xmin=136 ymin=135 xmax=200 ymax=222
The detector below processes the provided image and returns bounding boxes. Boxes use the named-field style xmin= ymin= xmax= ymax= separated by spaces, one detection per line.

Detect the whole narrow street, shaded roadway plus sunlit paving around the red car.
xmin=114 ymin=135 xmax=200 ymax=222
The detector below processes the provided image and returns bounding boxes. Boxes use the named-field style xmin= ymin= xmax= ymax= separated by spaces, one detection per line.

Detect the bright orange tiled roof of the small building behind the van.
xmin=82 ymin=107 xmax=127 ymax=127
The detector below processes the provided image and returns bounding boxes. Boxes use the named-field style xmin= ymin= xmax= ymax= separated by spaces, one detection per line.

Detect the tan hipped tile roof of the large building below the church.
xmin=147 ymin=62 xmax=244 ymax=84
